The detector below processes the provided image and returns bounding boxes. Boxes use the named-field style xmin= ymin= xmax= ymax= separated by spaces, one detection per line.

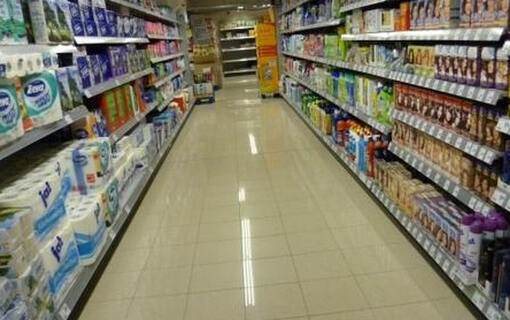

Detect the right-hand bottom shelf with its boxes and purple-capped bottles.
xmin=281 ymin=92 xmax=510 ymax=320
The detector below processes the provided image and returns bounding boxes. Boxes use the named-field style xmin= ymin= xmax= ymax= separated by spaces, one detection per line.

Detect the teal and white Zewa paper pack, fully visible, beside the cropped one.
xmin=21 ymin=70 xmax=62 ymax=127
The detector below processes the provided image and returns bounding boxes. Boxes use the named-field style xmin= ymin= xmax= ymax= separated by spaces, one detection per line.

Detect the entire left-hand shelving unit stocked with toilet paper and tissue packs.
xmin=0 ymin=0 xmax=194 ymax=319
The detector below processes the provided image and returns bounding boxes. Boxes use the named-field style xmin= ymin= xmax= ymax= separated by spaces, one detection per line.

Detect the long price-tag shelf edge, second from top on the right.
xmin=283 ymin=52 xmax=506 ymax=105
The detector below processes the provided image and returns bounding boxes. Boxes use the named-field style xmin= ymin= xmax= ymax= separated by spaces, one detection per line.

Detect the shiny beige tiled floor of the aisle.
xmin=80 ymin=78 xmax=474 ymax=320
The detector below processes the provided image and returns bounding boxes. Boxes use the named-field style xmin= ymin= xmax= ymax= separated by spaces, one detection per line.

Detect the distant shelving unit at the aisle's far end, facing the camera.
xmin=220 ymin=21 xmax=257 ymax=76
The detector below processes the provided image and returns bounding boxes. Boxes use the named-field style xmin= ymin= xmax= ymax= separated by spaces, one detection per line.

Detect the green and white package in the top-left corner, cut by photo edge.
xmin=0 ymin=0 xmax=28 ymax=44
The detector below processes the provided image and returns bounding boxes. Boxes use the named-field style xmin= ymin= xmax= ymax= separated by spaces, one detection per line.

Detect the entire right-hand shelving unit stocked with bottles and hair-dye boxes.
xmin=279 ymin=0 xmax=510 ymax=319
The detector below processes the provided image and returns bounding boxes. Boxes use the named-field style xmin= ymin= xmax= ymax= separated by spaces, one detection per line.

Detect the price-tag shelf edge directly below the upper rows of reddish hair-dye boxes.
xmin=390 ymin=109 xmax=503 ymax=165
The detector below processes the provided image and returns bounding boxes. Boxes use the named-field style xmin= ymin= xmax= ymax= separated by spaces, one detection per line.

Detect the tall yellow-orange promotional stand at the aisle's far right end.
xmin=256 ymin=23 xmax=278 ymax=94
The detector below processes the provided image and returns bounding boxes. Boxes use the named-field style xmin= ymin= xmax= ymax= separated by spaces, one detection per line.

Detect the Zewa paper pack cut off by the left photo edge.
xmin=0 ymin=80 xmax=25 ymax=146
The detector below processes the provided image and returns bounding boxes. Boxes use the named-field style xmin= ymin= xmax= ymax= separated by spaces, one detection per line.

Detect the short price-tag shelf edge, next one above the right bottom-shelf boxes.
xmin=389 ymin=141 xmax=493 ymax=214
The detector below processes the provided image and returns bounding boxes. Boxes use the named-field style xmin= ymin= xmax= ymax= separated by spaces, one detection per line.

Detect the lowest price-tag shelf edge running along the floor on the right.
xmin=282 ymin=90 xmax=509 ymax=320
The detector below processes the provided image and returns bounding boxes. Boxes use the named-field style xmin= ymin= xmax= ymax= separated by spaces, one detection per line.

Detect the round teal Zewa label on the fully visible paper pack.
xmin=21 ymin=72 xmax=58 ymax=117
